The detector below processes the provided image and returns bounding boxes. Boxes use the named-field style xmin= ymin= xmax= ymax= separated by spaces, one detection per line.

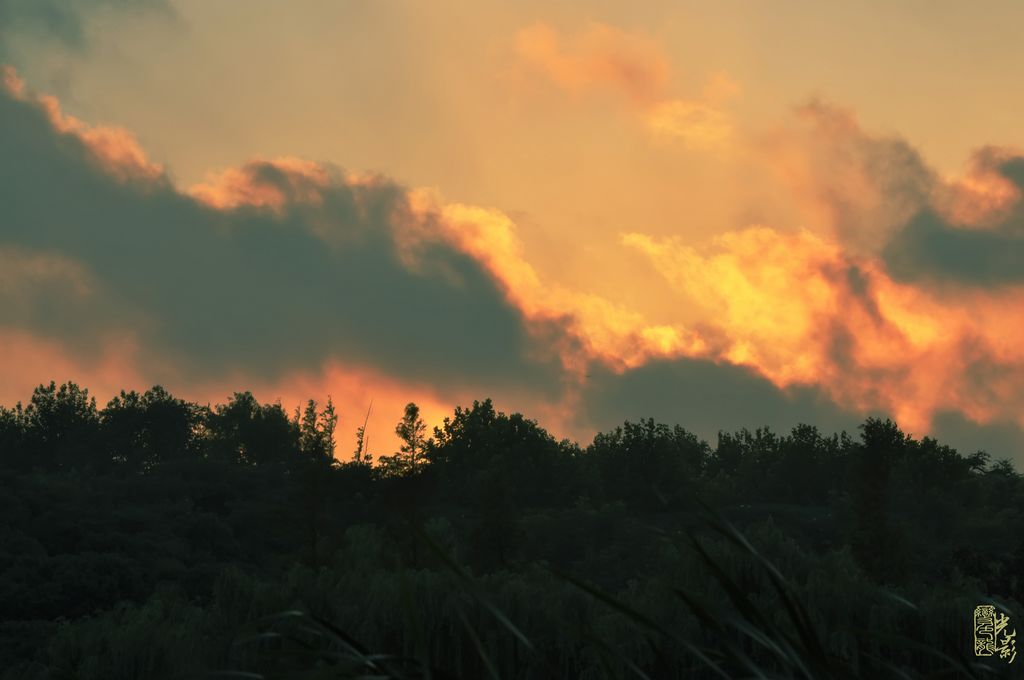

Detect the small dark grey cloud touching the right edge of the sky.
xmin=883 ymin=153 xmax=1024 ymax=286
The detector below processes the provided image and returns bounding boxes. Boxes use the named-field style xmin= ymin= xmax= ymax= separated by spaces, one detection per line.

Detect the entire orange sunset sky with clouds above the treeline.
xmin=0 ymin=0 xmax=1024 ymax=464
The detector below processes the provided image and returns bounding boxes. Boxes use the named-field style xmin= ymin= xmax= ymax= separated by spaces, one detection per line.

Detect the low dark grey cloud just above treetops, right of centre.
xmin=583 ymin=358 xmax=862 ymax=443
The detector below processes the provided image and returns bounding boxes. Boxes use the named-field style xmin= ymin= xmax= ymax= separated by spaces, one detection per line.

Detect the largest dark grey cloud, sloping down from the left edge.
xmin=0 ymin=82 xmax=559 ymax=391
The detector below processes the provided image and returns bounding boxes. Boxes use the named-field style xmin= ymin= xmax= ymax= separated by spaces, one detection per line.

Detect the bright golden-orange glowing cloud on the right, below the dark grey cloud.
xmin=625 ymin=227 xmax=1024 ymax=432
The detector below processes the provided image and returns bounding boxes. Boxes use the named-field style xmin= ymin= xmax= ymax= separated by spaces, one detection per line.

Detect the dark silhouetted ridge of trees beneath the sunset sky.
xmin=0 ymin=383 xmax=1024 ymax=680
